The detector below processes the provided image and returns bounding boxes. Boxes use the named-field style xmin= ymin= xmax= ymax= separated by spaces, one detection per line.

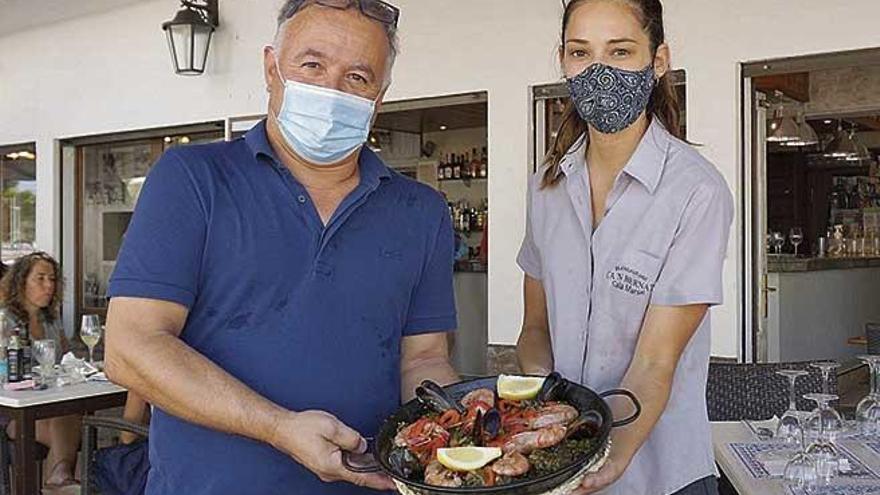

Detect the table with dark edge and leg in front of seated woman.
xmin=0 ymin=382 xmax=126 ymax=495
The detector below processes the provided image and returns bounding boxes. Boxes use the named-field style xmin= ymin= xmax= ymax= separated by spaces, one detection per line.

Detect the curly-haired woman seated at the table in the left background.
xmin=0 ymin=252 xmax=81 ymax=487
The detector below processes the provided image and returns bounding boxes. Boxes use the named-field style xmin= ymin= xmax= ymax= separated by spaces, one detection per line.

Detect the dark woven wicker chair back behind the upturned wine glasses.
xmin=706 ymin=362 xmax=837 ymax=421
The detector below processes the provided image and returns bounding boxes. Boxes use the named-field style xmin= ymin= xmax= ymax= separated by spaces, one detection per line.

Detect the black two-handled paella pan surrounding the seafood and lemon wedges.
xmin=343 ymin=373 xmax=641 ymax=495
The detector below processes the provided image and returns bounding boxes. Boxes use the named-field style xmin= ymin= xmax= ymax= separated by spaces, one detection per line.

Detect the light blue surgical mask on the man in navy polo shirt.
xmin=275 ymin=60 xmax=376 ymax=165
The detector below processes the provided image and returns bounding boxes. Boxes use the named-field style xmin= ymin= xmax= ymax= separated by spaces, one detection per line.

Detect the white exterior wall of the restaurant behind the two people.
xmin=0 ymin=0 xmax=880 ymax=356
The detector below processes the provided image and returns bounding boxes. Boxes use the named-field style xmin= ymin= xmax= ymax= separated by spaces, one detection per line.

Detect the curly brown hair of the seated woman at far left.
xmin=0 ymin=252 xmax=64 ymax=325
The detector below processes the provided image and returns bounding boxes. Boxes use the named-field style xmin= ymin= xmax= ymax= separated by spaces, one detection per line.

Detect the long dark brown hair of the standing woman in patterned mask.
xmin=541 ymin=0 xmax=683 ymax=187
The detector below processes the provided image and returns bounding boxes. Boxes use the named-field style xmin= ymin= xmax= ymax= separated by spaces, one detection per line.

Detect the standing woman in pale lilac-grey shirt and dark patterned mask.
xmin=517 ymin=0 xmax=733 ymax=495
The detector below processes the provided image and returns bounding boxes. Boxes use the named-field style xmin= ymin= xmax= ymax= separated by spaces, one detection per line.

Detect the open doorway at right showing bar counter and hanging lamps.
xmin=740 ymin=49 xmax=880 ymax=362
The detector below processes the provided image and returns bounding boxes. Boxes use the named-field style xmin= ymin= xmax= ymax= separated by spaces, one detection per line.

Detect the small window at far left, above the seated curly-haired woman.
xmin=0 ymin=144 xmax=37 ymax=264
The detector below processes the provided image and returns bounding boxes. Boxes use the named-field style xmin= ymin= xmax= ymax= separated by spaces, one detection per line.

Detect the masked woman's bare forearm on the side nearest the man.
xmin=516 ymin=275 xmax=553 ymax=375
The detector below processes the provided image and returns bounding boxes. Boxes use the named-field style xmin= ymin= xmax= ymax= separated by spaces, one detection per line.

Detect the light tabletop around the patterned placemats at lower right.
xmin=712 ymin=421 xmax=880 ymax=495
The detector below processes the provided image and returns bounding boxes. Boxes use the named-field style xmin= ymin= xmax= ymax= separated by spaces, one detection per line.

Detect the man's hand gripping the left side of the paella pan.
xmin=270 ymin=411 xmax=395 ymax=490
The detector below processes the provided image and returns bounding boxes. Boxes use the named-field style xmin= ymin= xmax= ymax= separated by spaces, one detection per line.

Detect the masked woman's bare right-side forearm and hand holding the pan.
xmin=573 ymin=304 xmax=708 ymax=495
